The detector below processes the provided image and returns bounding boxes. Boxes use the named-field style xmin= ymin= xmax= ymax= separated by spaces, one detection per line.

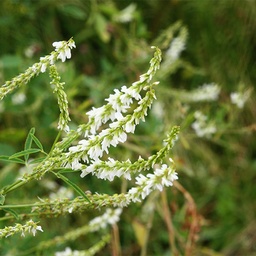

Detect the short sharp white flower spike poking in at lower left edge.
xmin=0 ymin=220 xmax=43 ymax=238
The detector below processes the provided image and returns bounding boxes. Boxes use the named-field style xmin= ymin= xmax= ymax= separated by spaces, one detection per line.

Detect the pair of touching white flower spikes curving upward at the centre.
xmin=66 ymin=48 xmax=161 ymax=172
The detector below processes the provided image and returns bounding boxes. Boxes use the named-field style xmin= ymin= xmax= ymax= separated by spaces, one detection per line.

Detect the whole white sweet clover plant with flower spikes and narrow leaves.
xmin=0 ymin=38 xmax=180 ymax=255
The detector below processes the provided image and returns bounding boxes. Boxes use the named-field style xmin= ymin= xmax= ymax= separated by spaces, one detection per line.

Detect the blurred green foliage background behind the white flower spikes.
xmin=0 ymin=0 xmax=256 ymax=256
